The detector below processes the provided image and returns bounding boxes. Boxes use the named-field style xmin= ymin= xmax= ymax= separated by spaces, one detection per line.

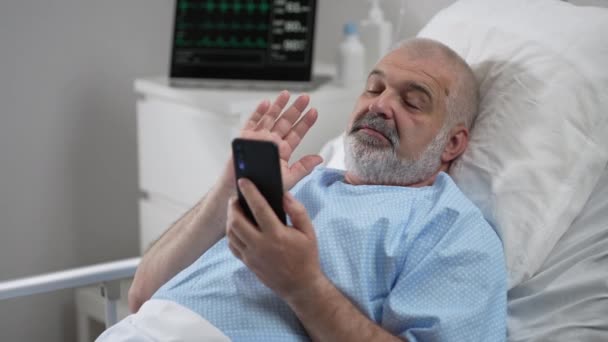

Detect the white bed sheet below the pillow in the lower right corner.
xmin=508 ymin=168 xmax=608 ymax=342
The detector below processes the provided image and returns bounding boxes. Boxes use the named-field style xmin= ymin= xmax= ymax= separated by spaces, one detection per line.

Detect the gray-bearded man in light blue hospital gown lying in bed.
xmin=101 ymin=39 xmax=506 ymax=341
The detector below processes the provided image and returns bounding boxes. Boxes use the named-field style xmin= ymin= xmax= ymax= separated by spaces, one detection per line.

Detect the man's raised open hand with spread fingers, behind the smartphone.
xmin=220 ymin=91 xmax=323 ymax=190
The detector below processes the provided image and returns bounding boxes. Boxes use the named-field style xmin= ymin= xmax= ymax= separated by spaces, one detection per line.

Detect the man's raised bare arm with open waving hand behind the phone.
xmin=129 ymin=91 xmax=322 ymax=312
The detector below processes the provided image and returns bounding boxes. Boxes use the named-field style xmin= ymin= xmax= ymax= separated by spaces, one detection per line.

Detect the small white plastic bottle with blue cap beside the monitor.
xmin=337 ymin=23 xmax=366 ymax=87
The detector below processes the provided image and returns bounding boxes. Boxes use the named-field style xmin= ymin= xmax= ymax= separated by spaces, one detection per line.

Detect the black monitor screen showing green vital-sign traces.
xmin=170 ymin=0 xmax=316 ymax=81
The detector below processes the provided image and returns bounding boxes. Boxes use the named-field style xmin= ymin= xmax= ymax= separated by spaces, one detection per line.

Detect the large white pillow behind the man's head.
xmin=325 ymin=0 xmax=608 ymax=288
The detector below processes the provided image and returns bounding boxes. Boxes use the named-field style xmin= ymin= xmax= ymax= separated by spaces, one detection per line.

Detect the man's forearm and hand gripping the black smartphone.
xmin=226 ymin=179 xmax=401 ymax=342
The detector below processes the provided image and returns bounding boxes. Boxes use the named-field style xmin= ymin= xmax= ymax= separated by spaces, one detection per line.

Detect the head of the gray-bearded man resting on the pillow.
xmin=345 ymin=38 xmax=478 ymax=186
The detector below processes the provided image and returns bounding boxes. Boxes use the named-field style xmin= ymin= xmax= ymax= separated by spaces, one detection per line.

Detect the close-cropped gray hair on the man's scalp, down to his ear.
xmin=394 ymin=38 xmax=479 ymax=129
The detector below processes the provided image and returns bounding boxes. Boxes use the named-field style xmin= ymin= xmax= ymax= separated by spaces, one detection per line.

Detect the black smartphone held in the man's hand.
xmin=232 ymin=138 xmax=287 ymax=225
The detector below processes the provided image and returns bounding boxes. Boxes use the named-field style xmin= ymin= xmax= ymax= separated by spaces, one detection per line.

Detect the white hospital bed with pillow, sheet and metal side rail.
xmin=0 ymin=0 xmax=608 ymax=341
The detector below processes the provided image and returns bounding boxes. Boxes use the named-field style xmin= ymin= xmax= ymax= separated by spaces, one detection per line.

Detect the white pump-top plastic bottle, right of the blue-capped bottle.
xmin=361 ymin=0 xmax=393 ymax=72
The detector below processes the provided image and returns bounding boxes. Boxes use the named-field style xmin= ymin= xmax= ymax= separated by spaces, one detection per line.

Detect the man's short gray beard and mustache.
xmin=344 ymin=114 xmax=450 ymax=185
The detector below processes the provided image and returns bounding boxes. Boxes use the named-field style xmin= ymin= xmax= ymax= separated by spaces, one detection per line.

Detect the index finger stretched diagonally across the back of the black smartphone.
xmin=238 ymin=178 xmax=283 ymax=232
